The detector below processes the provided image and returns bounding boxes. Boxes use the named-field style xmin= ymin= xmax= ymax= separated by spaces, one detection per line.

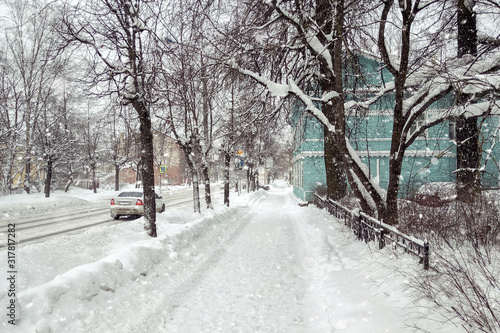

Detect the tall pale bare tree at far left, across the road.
xmin=1 ymin=1 xmax=64 ymax=193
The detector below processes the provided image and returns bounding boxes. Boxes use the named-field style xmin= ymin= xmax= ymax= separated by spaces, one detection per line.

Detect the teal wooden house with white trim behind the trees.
xmin=290 ymin=57 xmax=500 ymax=201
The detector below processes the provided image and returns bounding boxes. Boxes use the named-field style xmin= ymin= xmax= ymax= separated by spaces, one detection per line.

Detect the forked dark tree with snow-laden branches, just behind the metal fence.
xmin=340 ymin=0 xmax=495 ymax=224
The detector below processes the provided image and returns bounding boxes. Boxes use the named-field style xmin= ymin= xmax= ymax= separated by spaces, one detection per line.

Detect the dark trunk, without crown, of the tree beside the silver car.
xmin=132 ymin=102 xmax=157 ymax=237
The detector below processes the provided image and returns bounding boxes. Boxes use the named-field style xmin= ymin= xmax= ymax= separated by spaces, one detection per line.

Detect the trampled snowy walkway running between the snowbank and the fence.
xmin=157 ymin=188 xmax=306 ymax=332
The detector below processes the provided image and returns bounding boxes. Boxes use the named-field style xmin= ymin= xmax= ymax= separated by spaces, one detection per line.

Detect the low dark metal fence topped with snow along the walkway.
xmin=314 ymin=195 xmax=430 ymax=270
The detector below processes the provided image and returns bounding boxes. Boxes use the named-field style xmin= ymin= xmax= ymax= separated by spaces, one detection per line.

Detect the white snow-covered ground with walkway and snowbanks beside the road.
xmin=0 ymin=182 xmax=462 ymax=333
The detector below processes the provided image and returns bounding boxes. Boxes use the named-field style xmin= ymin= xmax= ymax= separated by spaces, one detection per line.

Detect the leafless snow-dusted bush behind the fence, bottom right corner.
xmin=401 ymin=192 xmax=500 ymax=332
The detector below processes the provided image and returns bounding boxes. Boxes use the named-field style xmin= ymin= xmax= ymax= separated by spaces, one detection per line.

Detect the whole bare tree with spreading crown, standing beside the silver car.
xmin=59 ymin=0 xmax=176 ymax=237
